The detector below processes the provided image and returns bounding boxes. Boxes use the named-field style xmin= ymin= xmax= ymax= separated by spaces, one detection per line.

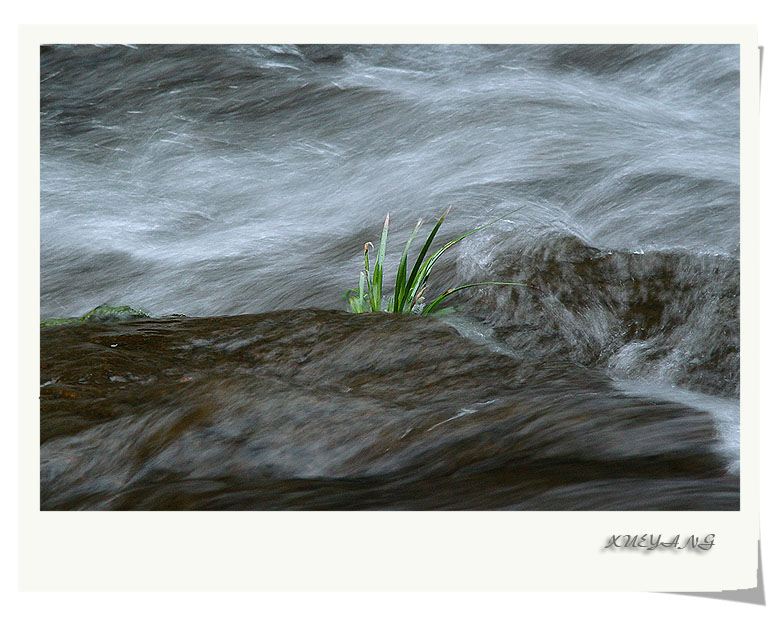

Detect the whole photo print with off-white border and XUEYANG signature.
xmin=22 ymin=27 xmax=759 ymax=591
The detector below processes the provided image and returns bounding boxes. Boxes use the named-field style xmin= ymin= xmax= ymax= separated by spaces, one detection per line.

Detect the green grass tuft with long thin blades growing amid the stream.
xmin=344 ymin=208 xmax=526 ymax=315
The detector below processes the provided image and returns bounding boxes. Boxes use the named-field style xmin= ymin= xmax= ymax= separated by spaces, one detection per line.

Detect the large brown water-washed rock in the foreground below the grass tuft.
xmin=41 ymin=310 xmax=739 ymax=509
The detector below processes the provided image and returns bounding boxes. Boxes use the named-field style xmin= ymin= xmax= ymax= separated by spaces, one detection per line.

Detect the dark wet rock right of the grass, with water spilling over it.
xmin=459 ymin=236 xmax=740 ymax=397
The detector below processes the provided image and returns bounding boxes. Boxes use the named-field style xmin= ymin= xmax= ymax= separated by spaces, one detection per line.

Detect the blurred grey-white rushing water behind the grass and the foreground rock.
xmin=41 ymin=45 xmax=739 ymax=508
